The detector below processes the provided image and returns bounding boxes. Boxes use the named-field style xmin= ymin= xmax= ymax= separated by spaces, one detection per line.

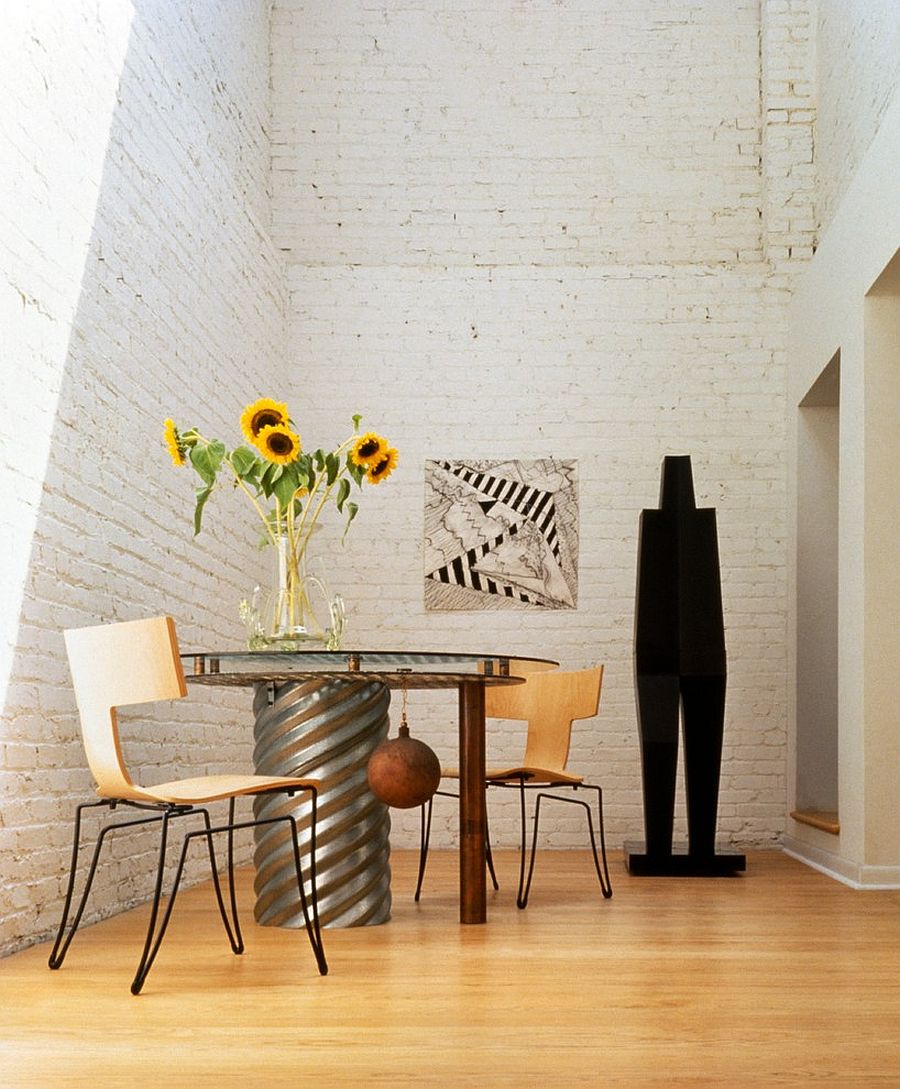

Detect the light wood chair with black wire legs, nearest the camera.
xmin=49 ymin=616 xmax=328 ymax=994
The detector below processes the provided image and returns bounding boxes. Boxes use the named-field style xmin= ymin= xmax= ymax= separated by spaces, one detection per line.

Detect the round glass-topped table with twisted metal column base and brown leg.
xmin=181 ymin=649 xmax=559 ymax=927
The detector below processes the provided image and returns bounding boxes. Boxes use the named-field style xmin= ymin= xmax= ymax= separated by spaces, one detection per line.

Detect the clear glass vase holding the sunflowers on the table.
xmin=241 ymin=536 xmax=344 ymax=650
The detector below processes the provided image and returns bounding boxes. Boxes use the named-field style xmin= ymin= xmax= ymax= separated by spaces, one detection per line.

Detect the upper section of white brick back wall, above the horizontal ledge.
xmin=272 ymin=0 xmax=761 ymax=267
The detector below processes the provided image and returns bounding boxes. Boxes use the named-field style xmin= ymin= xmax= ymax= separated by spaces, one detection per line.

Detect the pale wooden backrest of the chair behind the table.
xmin=485 ymin=665 xmax=604 ymax=771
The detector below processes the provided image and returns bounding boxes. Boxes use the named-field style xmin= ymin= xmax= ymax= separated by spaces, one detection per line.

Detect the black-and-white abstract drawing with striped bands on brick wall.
xmin=425 ymin=457 xmax=579 ymax=610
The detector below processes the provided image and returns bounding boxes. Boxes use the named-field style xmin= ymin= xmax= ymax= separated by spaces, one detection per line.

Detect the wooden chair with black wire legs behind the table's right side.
xmin=415 ymin=665 xmax=612 ymax=908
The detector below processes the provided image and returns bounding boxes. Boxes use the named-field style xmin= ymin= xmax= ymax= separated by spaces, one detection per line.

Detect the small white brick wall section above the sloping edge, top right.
xmin=816 ymin=0 xmax=900 ymax=238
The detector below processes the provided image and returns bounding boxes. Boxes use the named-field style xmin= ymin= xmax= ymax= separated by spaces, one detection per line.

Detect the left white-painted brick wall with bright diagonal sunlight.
xmin=0 ymin=0 xmax=284 ymax=955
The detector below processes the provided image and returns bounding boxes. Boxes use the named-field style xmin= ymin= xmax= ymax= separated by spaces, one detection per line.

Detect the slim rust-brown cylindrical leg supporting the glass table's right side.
xmin=460 ymin=680 xmax=487 ymax=922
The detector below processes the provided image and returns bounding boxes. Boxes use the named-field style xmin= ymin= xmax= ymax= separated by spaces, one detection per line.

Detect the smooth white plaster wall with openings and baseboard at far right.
xmin=786 ymin=65 xmax=900 ymax=886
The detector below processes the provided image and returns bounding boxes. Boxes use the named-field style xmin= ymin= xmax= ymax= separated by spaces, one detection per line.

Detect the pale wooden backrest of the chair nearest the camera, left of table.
xmin=63 ymin=616 xmax=187 ymax=798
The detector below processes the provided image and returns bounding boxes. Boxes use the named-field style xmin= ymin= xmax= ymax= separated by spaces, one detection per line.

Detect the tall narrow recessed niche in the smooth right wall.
xmin=792 ymin=351 xmax=840 ymax=832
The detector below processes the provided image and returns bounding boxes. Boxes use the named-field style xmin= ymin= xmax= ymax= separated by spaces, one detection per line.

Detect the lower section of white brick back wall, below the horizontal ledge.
xmin=290 ymin=265 xmax=786 ymax=846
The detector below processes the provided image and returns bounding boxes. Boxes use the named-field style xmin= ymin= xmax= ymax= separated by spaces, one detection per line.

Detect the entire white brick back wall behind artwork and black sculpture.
xmin=272 ymin=0 xmax=814 ymax=846
